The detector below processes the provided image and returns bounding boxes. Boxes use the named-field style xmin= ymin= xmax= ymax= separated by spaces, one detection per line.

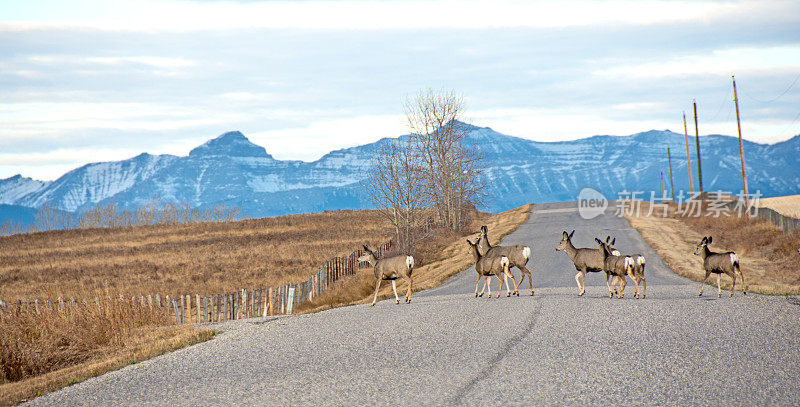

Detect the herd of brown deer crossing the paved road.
xmin=358 ymin=226 xmax=747 ymax=305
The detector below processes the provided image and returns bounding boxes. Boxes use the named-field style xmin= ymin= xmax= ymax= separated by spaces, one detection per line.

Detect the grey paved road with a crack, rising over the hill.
xmin=26 ymin=204 xmax=800 ymax=405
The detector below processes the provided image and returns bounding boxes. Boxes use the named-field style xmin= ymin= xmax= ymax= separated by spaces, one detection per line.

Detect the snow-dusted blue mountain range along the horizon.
xmin=0 ymin=126 xmax=800 ymax=222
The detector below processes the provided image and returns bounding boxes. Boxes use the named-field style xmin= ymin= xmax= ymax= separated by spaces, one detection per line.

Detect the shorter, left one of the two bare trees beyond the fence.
xmin=363 ymin=138 xmax=426 ymax=254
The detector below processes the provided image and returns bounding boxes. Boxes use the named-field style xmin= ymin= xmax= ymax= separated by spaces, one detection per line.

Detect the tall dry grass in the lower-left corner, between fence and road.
xmin=0 ymin=301 xmax=214 ymax=406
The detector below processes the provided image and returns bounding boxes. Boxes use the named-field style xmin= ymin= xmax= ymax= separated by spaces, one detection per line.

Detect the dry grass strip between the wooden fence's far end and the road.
xmin=298 ymin=204 xmax=531 ymax=313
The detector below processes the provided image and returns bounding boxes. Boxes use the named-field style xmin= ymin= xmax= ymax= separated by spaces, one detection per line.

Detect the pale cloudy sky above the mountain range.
xmin=0 ymin=0 xmax=800 ymax=180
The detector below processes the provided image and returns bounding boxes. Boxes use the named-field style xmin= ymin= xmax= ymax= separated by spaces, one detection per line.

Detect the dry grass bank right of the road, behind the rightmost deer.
xmin=626 ymin=202 xmax=800 ymax=295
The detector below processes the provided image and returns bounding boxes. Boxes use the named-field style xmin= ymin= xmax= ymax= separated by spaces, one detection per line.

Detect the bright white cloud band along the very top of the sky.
xmin=0 ymin=0 xmax=768 ymax=31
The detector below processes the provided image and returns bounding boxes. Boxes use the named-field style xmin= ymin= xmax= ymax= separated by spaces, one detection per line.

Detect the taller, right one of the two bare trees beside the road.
xmin=405 ymin=89 xmax=484 ymax=230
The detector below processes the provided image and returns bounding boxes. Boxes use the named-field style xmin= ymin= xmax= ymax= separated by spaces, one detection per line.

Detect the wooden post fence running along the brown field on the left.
xmin=0 ymin=243 xmax=391 ymax=324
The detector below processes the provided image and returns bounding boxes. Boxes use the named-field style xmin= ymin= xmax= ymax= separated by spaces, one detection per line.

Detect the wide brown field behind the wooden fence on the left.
xmin=0 ymin=211 xmax=392 ymax=303
